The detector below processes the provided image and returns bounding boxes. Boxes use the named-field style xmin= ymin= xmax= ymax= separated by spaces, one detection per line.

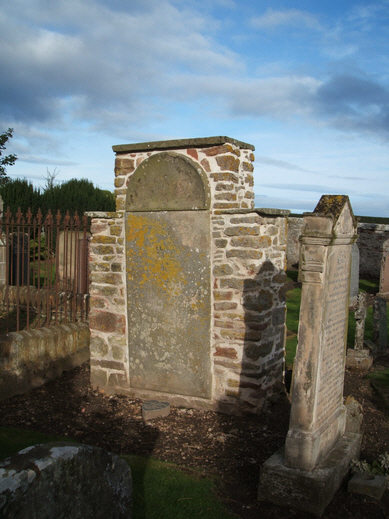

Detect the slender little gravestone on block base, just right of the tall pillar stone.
xmin=346 ymin=292 xmax=373 ymax=370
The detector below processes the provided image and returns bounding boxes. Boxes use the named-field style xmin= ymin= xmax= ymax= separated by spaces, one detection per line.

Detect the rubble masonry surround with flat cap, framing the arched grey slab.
xmin=90 ymin=137 xmax=288 ymax=412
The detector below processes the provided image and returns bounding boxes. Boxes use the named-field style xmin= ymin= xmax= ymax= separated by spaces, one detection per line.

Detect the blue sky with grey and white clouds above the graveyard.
xmin=0 ymin=0 xmax=389 ymax=216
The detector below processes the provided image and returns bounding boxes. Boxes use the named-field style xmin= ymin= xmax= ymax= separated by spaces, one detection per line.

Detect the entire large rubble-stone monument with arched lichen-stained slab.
xmin=89 ymin=137 xmax=289 ymax=413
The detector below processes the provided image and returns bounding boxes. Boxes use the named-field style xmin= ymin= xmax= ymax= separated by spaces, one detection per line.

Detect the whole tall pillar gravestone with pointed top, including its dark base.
xmin=258 ymin=195 xmax=362 ymax=516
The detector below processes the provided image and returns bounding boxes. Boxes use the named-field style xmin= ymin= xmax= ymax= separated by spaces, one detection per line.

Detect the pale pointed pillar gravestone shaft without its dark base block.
xmin=285 ymin=195 xmax=356 ymax=470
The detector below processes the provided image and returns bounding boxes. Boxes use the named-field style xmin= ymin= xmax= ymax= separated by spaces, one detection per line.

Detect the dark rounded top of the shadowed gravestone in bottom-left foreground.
xmin=0 ymin=442 xmax=132 ymax=519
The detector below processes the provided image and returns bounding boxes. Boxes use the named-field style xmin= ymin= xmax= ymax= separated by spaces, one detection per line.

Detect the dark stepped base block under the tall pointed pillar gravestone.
xmin=258 ymin=433 xmax=362 ymax=517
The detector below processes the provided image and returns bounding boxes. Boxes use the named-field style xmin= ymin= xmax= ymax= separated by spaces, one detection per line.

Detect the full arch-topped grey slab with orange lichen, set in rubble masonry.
xmin=126 ymin=153 xmax=211 ymax=398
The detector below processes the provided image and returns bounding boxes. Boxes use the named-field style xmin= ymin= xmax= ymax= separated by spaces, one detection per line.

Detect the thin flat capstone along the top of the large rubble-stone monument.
xmin=112 ymin=136 xmax=255 ymax=153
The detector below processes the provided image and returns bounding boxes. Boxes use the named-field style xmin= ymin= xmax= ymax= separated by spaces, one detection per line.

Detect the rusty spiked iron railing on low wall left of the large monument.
xmin=0 ymin=208 xmax=89 ymax=334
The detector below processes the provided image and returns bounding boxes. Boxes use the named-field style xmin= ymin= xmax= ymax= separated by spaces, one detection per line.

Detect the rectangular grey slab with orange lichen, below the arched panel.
xmin=126 ymin=211 xmax=211 ymax=398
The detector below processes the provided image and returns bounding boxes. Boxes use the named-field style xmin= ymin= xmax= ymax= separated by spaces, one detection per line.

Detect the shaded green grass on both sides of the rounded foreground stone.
xmin=0 ymin=427 xmax=233 ymax=519
